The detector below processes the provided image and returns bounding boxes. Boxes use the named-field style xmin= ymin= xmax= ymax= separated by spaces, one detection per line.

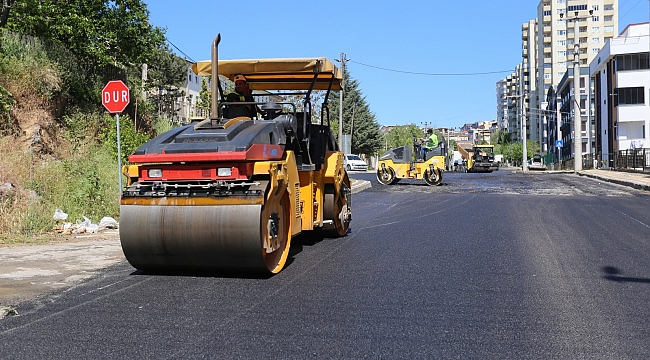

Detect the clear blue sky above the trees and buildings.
xmin=145 ymin=0 xmax=650 ymax=128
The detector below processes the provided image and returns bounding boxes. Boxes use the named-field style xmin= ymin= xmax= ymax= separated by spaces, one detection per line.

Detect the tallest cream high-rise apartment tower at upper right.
xmin=536 ymin=0 xmax=618 ymax=151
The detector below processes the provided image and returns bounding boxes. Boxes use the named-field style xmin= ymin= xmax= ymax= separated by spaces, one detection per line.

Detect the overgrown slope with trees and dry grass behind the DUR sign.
xmin=0 ymin=0 xmax=186 ymax=240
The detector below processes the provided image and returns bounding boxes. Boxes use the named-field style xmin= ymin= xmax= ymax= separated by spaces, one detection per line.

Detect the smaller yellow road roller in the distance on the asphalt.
xmin=377 ymin=138 xmax=448 ymax=185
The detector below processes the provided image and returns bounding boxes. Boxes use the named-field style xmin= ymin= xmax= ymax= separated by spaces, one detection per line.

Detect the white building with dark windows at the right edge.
xmin=589 ymin=23 xmax=650 ymax=166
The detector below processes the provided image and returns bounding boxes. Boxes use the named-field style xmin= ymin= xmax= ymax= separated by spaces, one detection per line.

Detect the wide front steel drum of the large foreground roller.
xmin=120 ymin=205 xmax=288 ymax=272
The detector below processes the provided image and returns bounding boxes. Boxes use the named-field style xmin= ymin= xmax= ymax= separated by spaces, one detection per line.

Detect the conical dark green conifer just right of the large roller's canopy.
xmin=329 ymin=71 xmax=385 ymax=154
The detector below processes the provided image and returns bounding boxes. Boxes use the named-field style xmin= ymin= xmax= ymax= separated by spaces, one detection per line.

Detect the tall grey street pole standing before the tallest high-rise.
xmin=560 ymin=10 xmax=594 ymax=174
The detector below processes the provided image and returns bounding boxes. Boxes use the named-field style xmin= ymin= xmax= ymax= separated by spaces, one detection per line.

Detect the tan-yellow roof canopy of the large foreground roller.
xmin=192 ymin=58 xmax=343 ymax=90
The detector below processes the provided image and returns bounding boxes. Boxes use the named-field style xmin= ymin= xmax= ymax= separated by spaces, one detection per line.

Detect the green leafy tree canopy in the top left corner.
xmin=0 ymin=0 xmax=165 ymax=66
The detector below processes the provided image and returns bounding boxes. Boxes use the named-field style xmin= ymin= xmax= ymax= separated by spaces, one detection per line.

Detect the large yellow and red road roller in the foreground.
xmin=119 ymin=35 xmax=352 ymax=275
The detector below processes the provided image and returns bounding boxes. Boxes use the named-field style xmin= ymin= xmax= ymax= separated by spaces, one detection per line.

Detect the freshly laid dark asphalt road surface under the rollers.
xmin=0 ymin=171 xmax=650 ymax=359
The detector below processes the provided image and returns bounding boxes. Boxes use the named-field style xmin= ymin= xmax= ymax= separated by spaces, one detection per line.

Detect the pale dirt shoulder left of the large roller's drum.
xmin=0 ymin=230 xmax=125 ymax=307
